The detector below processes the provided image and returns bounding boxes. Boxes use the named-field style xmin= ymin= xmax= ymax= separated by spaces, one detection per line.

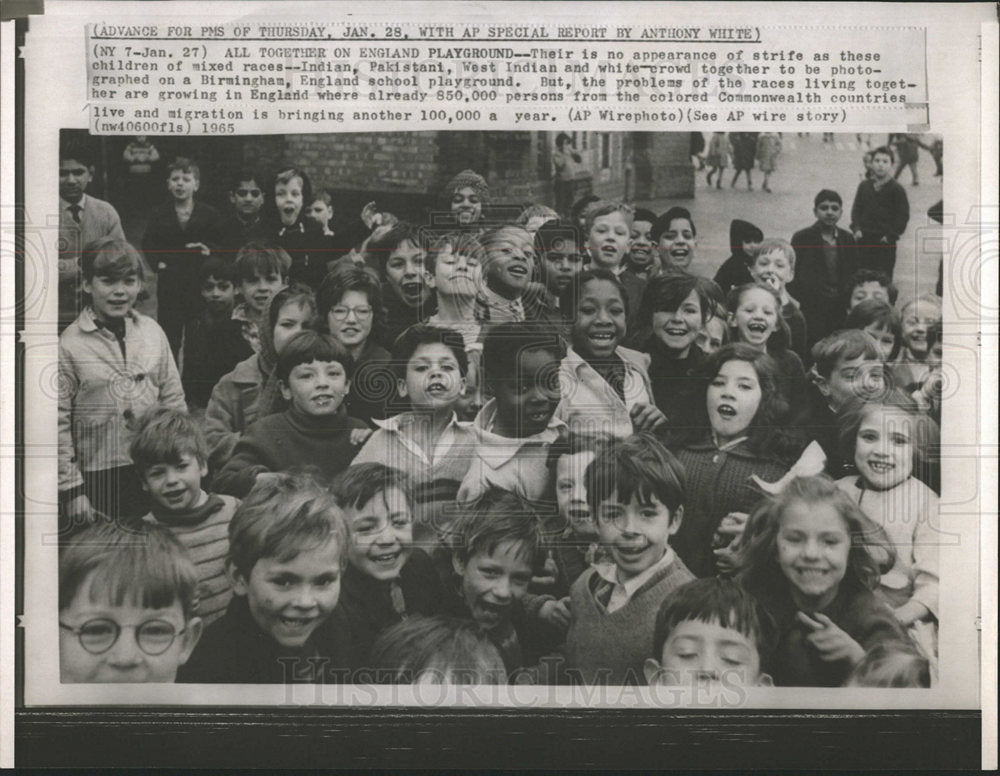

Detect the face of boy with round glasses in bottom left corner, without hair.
xmin=59 ymin=571 xmax=201 ymax=684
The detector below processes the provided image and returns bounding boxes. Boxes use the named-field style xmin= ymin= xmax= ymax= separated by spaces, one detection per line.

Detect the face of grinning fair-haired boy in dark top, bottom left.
xmin=232 ymin=539 xmax=340 ymax=648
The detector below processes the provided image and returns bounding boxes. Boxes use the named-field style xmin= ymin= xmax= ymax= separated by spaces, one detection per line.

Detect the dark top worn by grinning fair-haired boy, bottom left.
xmin=177 ymin=596 xmax=348 ymax=684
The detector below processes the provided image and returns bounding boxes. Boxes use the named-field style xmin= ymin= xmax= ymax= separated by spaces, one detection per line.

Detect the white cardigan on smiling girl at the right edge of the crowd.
xmin=837 ymin=477 xmax=943 ymax=617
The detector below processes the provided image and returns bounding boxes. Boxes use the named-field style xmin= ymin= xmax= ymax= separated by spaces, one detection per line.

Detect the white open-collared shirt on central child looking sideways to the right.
xmin=458 ymin=399 xmax=566 ymax=501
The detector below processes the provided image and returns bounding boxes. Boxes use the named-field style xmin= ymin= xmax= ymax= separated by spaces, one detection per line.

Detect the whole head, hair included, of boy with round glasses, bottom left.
xmin=59 ymin=523 xmax=202 ymax=684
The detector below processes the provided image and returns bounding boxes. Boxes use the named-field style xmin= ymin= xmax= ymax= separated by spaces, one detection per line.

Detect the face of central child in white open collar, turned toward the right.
xmin=494 ymin=348 xmax=559 ymax=437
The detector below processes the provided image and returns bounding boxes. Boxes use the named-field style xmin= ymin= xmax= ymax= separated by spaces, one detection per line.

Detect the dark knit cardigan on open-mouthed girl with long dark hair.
xmin=670 ymin=441 xmax=788 ymax=577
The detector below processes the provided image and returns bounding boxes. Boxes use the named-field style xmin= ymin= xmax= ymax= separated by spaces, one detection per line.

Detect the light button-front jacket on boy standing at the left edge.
xmin=58 ymin=307 xmax=187 ymax=490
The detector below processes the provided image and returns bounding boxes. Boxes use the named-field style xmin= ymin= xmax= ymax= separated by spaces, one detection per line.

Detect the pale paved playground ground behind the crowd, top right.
xmin=637 ymin=132 xmax=941 ymax=299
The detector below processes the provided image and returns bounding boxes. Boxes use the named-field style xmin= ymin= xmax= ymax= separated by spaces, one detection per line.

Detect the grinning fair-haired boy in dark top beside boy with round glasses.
xmin=178 ymin=474 xmax=348 ymax=684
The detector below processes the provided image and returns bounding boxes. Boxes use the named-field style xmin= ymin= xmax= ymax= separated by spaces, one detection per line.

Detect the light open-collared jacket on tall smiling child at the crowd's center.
xmin=556 ymin=347 xmax=654 ymax=437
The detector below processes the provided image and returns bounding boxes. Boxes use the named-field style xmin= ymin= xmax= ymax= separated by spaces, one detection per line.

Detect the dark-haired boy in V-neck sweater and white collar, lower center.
xmin=565 ymin=433 xmax=694 ymax=685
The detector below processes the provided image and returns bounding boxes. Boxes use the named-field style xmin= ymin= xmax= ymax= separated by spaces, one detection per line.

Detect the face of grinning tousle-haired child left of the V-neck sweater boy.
xmin=452 ymin=541 xmax=532 ymax=630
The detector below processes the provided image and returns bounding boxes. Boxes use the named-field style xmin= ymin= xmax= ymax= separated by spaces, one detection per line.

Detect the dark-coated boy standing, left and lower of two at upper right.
xmin=788 ymin=189 xmax=858 ymax=348
